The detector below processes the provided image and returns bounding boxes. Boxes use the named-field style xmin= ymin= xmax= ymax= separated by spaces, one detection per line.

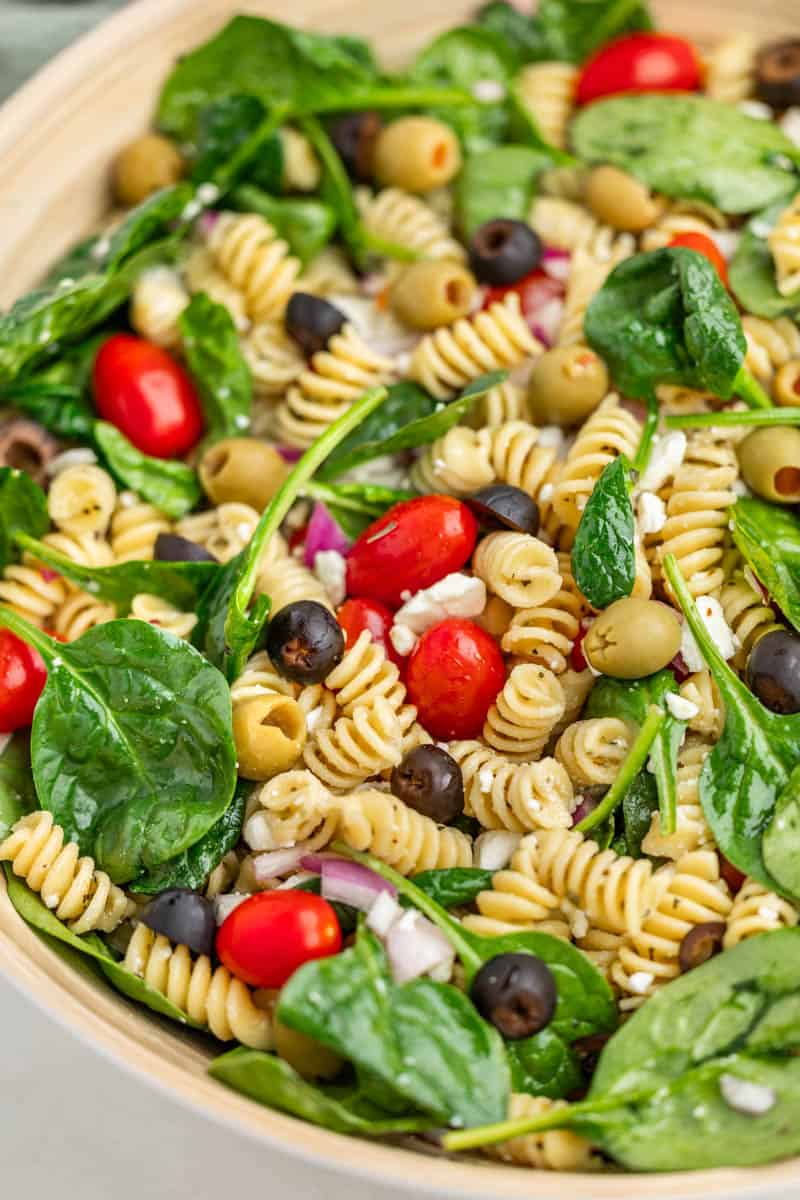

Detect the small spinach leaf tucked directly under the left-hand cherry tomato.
xmin=92 ymin=421 xmax=203 ymax=520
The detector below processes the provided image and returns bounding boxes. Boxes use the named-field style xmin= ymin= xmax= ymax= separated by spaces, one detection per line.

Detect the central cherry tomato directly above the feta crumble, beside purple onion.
xmin=347 ymin=496 xmax=477 ymax=608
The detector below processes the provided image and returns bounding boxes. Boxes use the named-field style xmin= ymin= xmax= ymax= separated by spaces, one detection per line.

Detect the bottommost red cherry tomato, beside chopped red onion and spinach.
xmin=217 ymin=890 xmax=342 ymax=988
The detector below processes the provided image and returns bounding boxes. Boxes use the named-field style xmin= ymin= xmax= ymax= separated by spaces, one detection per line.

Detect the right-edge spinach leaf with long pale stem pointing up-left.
xmin=664 ymin=554 xmax=800 ymax=899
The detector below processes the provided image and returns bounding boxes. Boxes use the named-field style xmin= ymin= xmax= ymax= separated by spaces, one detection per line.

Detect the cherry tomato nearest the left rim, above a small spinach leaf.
xmin=92 ymin=334 xmax=204 ymax=458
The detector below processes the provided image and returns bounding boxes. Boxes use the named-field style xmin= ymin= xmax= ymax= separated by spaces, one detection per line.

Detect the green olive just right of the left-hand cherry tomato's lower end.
xmin=198 ymin=438 xmax=289 ymax=512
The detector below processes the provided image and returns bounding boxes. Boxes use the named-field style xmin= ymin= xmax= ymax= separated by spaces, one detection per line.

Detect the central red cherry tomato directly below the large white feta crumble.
xmin=408 ymin=617 xmax=506 ymax=738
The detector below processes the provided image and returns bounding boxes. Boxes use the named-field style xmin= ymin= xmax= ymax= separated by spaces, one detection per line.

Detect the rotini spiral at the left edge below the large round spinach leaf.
xmin=0 ymin=811 xmax=133 ymax=934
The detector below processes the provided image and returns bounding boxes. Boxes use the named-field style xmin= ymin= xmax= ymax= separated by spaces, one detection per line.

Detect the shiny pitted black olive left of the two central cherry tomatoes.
xmin=266 ymin=600 xmax=344 ymax=683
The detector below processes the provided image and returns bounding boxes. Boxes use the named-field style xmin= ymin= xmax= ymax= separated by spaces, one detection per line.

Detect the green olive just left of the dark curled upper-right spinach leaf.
xmin=528 ymin=344 xmax=609 ymax=426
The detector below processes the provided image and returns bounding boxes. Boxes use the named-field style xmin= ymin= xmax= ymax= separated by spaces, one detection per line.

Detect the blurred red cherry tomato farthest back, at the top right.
xmin=577 ymin=34 xmax=702 ymax=104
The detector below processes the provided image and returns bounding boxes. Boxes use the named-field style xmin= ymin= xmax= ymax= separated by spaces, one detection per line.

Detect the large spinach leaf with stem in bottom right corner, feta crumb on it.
xmin=443 ymin=929 xmax=800 ymax=1171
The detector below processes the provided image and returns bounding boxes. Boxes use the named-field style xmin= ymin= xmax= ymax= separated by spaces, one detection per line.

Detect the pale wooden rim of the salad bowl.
xmin=0 ymin=0 xmax=800 ymax=1200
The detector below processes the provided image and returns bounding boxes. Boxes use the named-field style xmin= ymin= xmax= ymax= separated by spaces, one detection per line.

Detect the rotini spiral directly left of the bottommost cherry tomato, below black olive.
xmin=124 ymin=925 xmax=272 ymax=1050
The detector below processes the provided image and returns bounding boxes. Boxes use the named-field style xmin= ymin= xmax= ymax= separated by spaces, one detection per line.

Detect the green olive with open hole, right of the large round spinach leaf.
xmin=233 ymin=692 xmax=306 ymax=780
